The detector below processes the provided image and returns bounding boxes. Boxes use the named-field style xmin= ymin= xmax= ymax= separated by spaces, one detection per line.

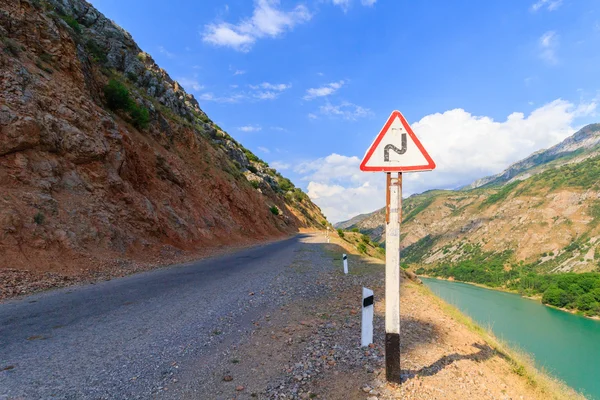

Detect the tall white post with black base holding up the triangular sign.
xmin=385 ymin=172 xmax=402 ymax=383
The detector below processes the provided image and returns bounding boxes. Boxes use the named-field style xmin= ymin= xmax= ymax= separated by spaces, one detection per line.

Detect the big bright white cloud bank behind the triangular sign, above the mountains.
xmin=295 ymin=99 xmax=597 ymax=222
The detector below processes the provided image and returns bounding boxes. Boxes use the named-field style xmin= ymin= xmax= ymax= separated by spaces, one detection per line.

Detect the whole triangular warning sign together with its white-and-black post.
xmin=360 ymin=111 xmax=435 ymax=383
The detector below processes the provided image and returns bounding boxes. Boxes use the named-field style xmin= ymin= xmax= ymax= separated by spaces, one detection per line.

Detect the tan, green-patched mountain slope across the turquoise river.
xmin=338 ymin=124 xmax=600 ymax=272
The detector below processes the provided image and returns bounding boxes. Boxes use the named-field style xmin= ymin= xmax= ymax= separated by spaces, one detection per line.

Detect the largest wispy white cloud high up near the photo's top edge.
xmin=202 ymin=0 xmax=312 ymax=52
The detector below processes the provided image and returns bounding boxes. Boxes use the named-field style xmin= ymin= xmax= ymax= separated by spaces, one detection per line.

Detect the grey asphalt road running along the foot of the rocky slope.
xmin=0 ymin=235 xmax=310 ymax=399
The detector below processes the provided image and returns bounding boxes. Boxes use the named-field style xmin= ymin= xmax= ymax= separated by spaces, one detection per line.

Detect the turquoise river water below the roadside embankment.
xmin=422 ymin=278 xmax=600 ymax=400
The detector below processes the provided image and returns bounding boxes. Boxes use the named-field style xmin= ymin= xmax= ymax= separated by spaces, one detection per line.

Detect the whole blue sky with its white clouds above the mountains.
xmin=92 ymin=0 xmax=600 ymax=221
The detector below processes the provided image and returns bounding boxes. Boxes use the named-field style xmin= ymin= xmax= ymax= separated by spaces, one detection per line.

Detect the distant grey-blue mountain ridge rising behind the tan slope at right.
xmin=463 ymin=124 xmax=600 ymax=189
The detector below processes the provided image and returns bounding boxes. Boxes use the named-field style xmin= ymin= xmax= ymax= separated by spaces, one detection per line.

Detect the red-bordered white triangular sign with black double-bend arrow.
xmin=360 ymin=111 xmax=435 ymax=172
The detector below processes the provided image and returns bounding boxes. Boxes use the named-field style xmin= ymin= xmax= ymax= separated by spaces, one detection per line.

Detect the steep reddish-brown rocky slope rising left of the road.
xmin=0 ymin=0 xmax=325 ymax=290
